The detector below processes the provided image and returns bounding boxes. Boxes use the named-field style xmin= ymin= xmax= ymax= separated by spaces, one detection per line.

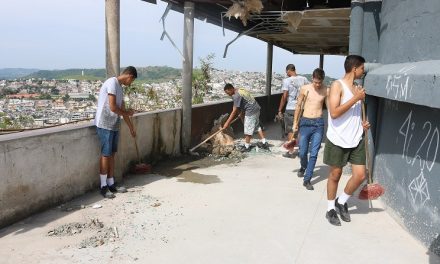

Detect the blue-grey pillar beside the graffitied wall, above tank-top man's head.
xmin=348 ymin=0 xmax=364 ymax=55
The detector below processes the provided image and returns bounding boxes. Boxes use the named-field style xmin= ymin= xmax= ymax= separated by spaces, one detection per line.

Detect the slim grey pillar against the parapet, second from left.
xmin=181 ymin=2 xmax=194 ymax=152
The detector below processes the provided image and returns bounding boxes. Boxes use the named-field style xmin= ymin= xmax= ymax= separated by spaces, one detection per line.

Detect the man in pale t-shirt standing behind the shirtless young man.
xmin=278 ymin=64 xmax=310 ymax=158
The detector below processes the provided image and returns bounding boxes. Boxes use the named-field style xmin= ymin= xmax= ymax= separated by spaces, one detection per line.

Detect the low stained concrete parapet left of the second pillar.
xmin=0 ymin=109 xmax=181 ymax=227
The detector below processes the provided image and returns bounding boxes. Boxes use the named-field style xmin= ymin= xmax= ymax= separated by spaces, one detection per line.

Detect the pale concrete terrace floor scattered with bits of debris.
xmin=0 ymin=124 xmax=440 ymax=264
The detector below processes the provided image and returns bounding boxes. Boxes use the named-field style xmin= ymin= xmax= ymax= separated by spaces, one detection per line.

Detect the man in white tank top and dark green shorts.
xmin=324 ymin=55 xmax=370 ymax=226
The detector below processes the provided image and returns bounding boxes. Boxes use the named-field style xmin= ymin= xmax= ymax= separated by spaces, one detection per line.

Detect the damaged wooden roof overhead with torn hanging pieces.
xmin=144 ymin=0 xmax=351 ymax=55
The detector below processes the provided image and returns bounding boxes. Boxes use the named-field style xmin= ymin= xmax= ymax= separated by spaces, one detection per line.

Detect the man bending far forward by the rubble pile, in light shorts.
xmin=222 ymin=83 xmax=269 ymax=152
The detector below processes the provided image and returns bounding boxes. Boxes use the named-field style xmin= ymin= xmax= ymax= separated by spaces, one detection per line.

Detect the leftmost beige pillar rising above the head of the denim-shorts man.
xmin=105 ymin=0 xmax=120 ymax=78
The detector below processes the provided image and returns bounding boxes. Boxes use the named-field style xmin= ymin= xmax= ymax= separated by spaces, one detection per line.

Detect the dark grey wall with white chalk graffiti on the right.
xmin=350 ymin=0 xmax=440 ymax=254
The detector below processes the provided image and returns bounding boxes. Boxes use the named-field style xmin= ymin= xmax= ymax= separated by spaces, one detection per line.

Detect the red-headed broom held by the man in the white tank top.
xmin=359 ymin=102 xmax=385 ymax=200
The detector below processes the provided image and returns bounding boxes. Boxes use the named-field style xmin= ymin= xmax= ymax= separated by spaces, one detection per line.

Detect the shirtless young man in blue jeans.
xmin=293 ymin=68 xmax=328 ymax=190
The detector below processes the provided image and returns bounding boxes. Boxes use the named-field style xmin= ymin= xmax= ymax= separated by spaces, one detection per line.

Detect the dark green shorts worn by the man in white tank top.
xmin=324 ymin=137 xmax=366 ymax=168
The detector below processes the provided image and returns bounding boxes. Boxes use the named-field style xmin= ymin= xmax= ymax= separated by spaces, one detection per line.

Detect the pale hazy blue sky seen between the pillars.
xmin=0 ymin=0 xmax=345 ymax=78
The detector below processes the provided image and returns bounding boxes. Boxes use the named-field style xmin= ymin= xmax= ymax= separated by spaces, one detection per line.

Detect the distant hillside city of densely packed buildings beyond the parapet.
xmin=0 ymin=69 xmax=285 ymax=131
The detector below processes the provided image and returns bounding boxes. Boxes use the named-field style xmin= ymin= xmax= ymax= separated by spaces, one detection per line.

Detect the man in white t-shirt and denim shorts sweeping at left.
xmin=95 ymin=66 xmax=137 ymax=198
